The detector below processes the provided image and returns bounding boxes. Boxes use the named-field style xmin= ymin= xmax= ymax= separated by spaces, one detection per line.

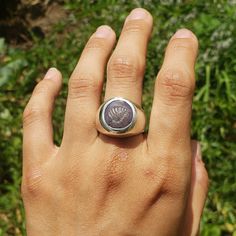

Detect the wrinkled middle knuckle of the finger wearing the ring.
xmin=108 ymin=55 xmax=144 ymax=84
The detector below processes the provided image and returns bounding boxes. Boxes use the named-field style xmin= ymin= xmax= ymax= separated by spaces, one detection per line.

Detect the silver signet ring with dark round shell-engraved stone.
xmin=96 ymin=97 xmax=146 ymax=137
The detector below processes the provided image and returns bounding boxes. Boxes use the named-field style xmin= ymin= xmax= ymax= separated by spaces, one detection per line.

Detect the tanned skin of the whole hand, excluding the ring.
xmin=22 ymin=8 xmax=208 ymax=236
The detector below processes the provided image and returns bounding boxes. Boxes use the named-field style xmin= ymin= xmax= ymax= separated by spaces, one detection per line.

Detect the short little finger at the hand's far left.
xmin=23 ymin=68 xmax=62 ymax=165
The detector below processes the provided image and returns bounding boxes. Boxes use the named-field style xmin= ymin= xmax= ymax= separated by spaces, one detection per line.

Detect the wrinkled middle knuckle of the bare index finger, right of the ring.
xmin=157 ymin=70 xmax=194 ymax=102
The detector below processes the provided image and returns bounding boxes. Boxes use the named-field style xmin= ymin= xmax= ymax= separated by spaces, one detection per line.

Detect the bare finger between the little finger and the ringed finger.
xmin=63 ymin=26 xmax=115 ymax=144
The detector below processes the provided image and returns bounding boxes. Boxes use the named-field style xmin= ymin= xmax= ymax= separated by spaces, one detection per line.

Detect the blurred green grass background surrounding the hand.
xmin=0 ymin=0 xmax=236 ymax=236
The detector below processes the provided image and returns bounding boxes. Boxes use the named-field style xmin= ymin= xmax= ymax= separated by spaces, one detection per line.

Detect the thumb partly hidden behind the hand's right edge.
xmin=185 ymin=141 xmax=208 ymax=236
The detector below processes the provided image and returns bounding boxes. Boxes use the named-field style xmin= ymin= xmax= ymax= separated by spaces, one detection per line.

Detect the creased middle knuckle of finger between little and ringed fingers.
xmin=69 ymin=74 xmax=101 ymax=99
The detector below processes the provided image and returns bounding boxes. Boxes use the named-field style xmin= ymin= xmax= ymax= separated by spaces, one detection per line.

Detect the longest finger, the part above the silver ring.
xmin=105 ymin=8 xmax=152 ymax=105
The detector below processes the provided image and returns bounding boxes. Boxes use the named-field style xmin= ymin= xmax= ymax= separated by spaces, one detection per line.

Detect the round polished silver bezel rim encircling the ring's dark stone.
xmin=99 ymin=97 xmax=137 ymax=133
